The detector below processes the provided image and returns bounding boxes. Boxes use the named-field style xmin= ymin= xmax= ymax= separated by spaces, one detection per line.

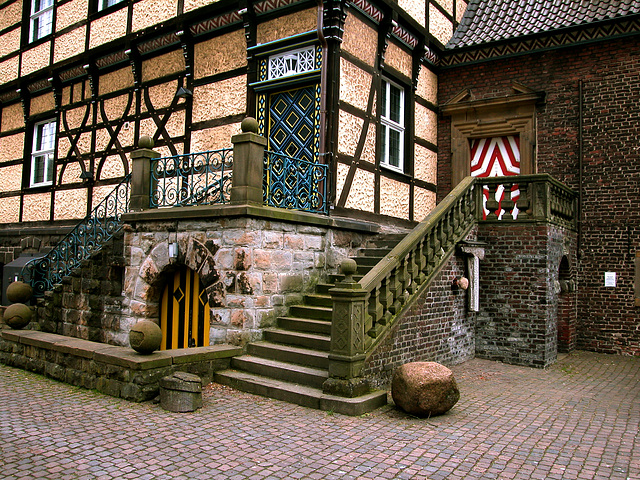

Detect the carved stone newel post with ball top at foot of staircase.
xmin=322 ymin=259 xmax=369 ymax=397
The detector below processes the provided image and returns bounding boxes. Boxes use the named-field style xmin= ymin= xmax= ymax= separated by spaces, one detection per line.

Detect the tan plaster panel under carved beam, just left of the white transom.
xmin=193 ymin=30 xmax=247 ymax=78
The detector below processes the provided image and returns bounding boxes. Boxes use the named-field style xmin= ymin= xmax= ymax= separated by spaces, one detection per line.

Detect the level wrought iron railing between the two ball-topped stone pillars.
xmin=149 ymin=148 xmax=233 ymax=208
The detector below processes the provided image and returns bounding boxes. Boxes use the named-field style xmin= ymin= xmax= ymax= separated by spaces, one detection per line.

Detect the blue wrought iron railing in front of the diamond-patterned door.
xmin=264 ymin=151 xmax=328 ymax=214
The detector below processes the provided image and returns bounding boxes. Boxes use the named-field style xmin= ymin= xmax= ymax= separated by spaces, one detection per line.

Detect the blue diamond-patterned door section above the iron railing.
xmin=268 ymin=87 xmax=316 ymax=162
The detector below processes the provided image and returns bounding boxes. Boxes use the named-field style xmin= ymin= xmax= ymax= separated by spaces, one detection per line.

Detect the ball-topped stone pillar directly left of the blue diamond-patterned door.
xmin=231 ymin=117 xmax=267 ymax=205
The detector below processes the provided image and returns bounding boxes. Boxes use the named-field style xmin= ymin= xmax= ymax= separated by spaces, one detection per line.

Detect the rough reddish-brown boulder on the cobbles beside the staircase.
xmin=391 ymin=362 xmax=460 ymax=417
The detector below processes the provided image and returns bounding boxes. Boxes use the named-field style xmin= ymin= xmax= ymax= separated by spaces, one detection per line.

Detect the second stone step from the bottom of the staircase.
xmin=231 ymin=355 xmax=329 ymax=388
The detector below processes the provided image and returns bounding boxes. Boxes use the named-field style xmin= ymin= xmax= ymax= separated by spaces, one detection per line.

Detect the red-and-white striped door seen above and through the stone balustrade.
xmin=470 ymin=135 xmax=520 ymax=218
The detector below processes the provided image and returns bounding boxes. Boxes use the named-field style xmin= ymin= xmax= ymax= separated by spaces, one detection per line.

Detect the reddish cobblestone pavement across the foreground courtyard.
xmin=0 ymin=352 xmax=640 ymax=480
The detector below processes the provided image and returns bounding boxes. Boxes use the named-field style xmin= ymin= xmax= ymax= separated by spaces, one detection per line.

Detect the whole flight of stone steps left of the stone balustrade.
xmin=214 ymin=234 xmax=404 ymax=415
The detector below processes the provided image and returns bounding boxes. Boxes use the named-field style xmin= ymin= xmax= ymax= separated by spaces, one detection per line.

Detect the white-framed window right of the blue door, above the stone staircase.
xmin=380 ymin=80 xmax=404 ymax=172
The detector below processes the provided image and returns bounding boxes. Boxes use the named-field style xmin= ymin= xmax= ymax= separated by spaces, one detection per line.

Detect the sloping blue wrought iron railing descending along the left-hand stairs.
xmin=20 ymin=175 xmax=131 ymax=296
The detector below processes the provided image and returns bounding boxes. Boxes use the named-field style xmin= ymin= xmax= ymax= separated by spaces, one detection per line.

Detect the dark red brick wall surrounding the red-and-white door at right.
xmin=438 ymin=37 xmax=640 ymax=355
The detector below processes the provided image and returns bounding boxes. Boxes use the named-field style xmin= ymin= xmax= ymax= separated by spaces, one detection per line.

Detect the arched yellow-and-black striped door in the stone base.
xmin=160 ymin=267 xmax=210 ymax=350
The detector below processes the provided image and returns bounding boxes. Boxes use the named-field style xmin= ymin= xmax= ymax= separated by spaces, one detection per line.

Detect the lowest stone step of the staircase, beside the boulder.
xmin=214 ymin=370 xmax=387 ymax=416
